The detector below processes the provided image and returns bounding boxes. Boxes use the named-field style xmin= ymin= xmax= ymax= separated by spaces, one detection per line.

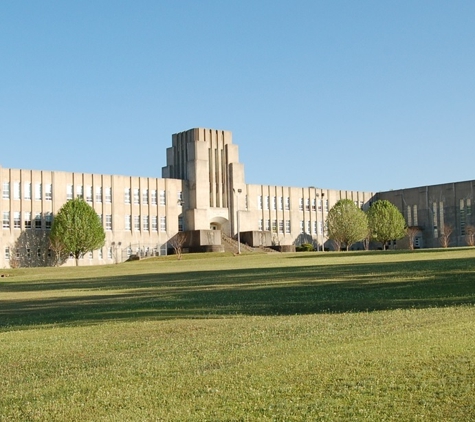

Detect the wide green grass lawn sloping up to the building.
xmin=0 ymin=248 xmax=475 ymax=421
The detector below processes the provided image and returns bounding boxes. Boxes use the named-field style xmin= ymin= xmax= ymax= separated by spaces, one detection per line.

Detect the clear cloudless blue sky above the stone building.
xmin=0 ymin=0 xmax=475 ymax=191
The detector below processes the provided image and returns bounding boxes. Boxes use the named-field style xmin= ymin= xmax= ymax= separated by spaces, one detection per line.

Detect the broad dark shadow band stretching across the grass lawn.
xmin=0 ymin=254 xmax=475 ymax=330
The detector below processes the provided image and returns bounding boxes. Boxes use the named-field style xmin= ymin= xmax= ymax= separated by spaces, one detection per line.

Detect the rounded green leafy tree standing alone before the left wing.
xmin=50 ymin=198 xmax=106 ymax=265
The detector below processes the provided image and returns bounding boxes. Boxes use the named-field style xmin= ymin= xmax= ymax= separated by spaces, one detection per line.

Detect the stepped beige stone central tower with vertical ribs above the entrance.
xmin=162 ymin=128 xmax=245 ymax=235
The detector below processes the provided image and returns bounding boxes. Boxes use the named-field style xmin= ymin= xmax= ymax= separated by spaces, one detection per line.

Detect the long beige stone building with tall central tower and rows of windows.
xmin=0 ymin=128 xmax=475 ymax=268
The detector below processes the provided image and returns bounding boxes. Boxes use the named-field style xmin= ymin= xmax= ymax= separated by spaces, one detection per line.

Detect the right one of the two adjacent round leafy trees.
xmin=368 ymin=200 xmax=406 ymax=249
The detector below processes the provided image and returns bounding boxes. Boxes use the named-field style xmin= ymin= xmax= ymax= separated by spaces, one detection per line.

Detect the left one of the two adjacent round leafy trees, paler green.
xmin=327 ymin=199 xmax=368 ymax=250
